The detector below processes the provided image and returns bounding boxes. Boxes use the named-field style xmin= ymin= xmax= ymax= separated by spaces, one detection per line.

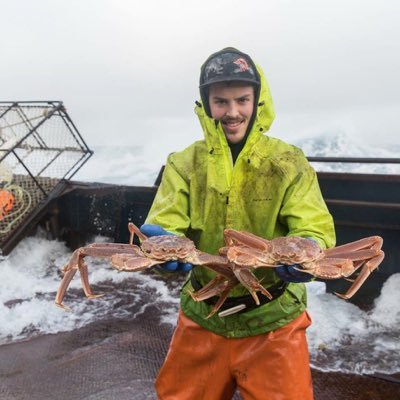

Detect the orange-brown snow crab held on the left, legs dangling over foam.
xmin=55 ymin=223 xmax=233 ymax=310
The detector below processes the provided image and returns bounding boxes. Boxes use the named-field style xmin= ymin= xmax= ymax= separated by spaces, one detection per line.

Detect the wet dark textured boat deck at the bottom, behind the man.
xmin=0 ymin=306 xmax=400 ymax=400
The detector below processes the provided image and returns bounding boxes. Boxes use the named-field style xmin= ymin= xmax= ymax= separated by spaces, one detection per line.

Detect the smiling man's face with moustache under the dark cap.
xmin=209 ymin=82 xmax=254 ymax=143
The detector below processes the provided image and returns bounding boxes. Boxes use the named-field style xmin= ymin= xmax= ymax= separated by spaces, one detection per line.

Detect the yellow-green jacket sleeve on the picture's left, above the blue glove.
xmin=146 ymin=156 xmax=190 ymax=235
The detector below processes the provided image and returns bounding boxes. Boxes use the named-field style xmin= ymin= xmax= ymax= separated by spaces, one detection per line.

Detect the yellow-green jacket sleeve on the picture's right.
xmin=279 ymin=160 xmax=336 ymax=248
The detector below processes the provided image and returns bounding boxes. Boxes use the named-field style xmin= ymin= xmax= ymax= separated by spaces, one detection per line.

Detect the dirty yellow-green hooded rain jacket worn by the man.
xmin=146 ymin=63 xmax=335 ymax=337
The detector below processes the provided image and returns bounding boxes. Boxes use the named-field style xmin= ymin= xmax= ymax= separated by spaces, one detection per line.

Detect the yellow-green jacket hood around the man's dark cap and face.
xmin=195 ymin=64 xmax=275 ymax=152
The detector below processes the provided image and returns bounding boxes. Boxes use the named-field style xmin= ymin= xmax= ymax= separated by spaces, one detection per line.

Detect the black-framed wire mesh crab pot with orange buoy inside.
xmin=0 ymin=101 xmax=92 ymax=255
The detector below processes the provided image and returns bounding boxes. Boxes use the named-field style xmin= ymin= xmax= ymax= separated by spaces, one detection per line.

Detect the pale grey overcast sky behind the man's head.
xmin=0 ymin=0 xmax=400 ymax=156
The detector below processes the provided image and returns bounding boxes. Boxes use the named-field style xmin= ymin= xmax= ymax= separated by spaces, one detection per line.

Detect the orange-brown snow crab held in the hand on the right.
xmin=220 ymin=229 xmax=384 ymax=304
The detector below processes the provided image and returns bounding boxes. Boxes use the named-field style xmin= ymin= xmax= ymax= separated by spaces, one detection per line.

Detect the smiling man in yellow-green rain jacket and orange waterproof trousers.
xmin=141 ymin=48 xmax=335 ymax=400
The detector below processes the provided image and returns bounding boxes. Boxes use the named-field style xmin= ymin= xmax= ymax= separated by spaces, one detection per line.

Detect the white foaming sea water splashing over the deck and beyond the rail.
xmin=0 ymin=135 xmax=400 ymax=373
